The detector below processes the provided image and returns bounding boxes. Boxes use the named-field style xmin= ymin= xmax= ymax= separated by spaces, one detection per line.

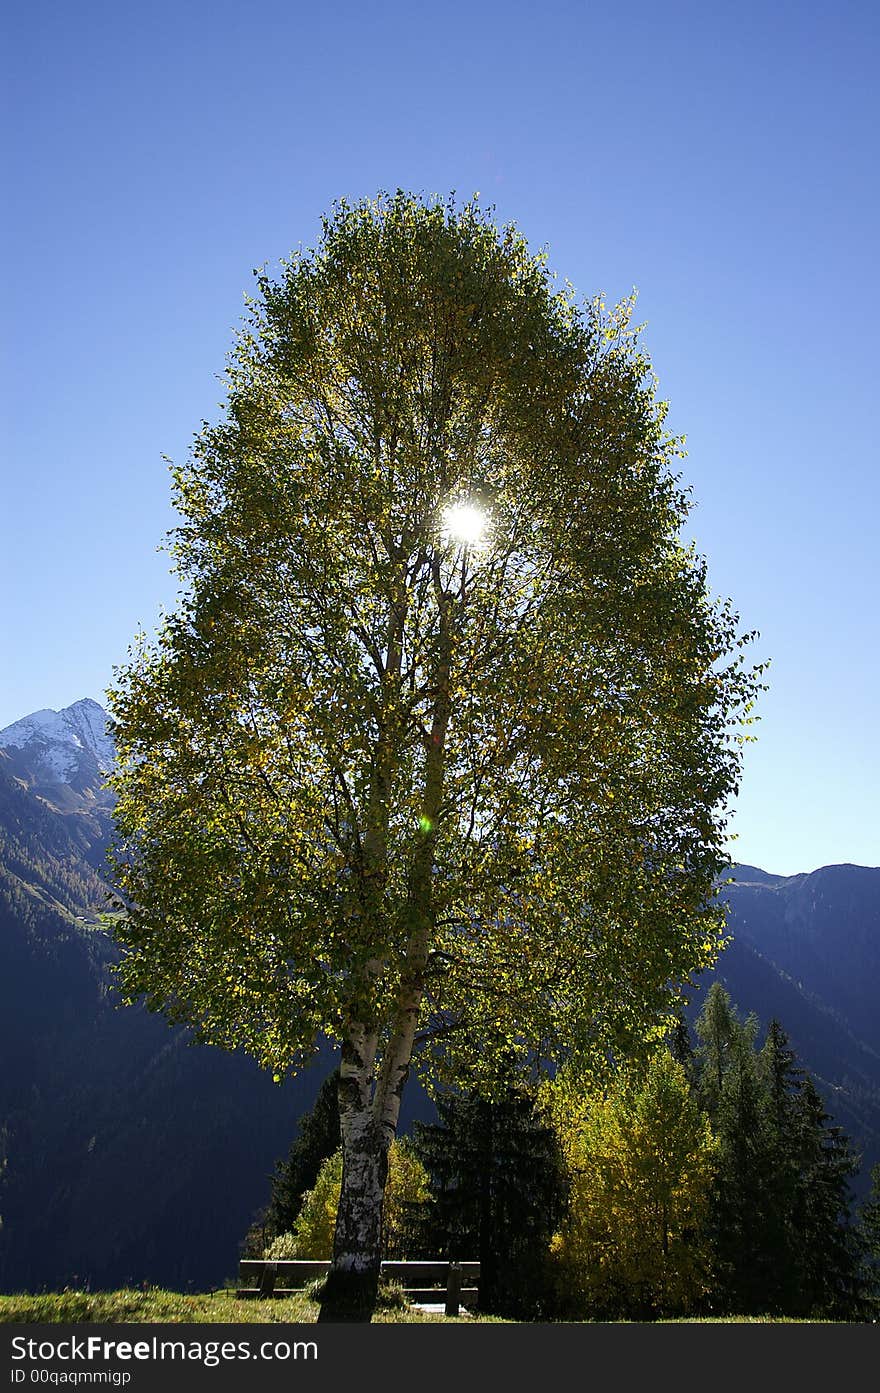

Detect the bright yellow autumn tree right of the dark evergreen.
xmin=551 ymin=1049 xmax=717 ymax=1319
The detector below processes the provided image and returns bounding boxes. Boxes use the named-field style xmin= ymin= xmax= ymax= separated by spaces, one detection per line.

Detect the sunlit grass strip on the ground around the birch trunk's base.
xmin=0 ymin=1287 xmax=493 ymax=1325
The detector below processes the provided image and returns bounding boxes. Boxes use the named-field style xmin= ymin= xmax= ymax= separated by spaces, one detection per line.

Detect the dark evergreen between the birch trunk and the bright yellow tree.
xmin=414 ymin=1085 xmax=567 ymax=1316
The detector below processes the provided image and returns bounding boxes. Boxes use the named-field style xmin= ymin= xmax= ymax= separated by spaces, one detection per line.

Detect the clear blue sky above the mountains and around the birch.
xmin=0 ymin=0 xmax=880 ymax=875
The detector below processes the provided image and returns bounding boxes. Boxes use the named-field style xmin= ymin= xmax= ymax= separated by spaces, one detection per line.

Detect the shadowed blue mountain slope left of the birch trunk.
xmin=0 ymin=713 xmax=331 ymax=1290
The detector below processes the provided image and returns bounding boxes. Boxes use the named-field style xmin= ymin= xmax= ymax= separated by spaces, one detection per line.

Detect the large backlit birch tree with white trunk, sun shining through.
xmin=110 ymin=192 xmax=757 ymax=1315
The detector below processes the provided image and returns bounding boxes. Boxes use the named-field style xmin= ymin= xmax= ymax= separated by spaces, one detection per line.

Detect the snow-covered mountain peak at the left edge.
xmin=0 ymin=697 xmax=116 ymax=783
